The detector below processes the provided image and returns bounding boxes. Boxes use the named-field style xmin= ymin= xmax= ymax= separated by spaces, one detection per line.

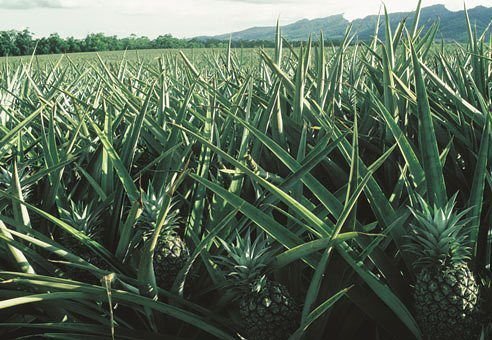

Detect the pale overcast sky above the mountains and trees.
xmin=0 ymin=0 xmax=492 ymax=38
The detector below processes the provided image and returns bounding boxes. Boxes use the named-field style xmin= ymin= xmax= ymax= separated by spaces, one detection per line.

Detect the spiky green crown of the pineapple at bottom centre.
xmin=217 ymin=231 xmax=273 ymax=288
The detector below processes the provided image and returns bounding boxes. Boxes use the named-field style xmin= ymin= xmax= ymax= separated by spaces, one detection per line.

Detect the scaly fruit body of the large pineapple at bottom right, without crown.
xmin=414 ymin=264 xmax=481 ymax=340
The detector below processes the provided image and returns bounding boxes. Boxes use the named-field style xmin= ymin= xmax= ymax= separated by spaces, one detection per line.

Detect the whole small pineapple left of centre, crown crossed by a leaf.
xmin=138 ymin=183 xmax=190 ymax=290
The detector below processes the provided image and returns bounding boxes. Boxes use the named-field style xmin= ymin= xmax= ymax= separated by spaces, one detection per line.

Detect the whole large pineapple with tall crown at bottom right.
xmin=407 ymin=196 xmax=480 ymax=340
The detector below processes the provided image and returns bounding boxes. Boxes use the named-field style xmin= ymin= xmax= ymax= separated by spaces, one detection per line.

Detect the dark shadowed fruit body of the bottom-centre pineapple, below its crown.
xmin=239 ymin=280 xmax=300 ymax=340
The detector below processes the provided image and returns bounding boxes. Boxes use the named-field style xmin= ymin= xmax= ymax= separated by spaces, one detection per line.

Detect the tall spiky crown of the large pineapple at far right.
xmin=406 ymin=195 xmax=471 ymax=268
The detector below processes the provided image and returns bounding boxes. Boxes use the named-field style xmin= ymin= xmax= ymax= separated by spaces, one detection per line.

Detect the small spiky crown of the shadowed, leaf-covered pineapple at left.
xmin=60 ymin=200 xmax=100 ymax=237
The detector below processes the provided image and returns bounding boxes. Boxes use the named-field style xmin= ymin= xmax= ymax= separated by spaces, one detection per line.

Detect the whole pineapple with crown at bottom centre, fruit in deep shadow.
xmin=218 ymin=232 xmax=300 ymax=340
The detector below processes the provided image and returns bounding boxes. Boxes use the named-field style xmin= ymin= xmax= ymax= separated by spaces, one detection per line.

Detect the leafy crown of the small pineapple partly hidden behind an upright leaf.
xmin=138 ymin=183 xmax=179 ymax=234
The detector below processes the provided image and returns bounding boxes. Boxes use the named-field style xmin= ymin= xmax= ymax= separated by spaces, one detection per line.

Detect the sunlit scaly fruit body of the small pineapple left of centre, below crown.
xmin=154 ymin=234 xmax=190 ymax=290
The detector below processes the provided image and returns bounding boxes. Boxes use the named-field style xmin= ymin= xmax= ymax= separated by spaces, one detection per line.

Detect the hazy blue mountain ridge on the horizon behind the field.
xmin=197 ymin=5 xmax=492 ymax=41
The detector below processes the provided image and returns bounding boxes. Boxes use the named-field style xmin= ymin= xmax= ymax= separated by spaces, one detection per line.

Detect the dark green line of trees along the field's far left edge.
xmin=0 ymin=29 xmax=284 ymax=56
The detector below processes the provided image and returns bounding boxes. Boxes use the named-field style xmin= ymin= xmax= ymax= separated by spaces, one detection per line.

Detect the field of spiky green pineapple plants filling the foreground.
xmin=0 ymin=4 xmax=492 ymax=340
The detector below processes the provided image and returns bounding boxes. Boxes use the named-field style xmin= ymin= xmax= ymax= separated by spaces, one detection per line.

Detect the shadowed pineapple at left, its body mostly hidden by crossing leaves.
xmin=60 ymin=201 xmax=108 ymax=283
